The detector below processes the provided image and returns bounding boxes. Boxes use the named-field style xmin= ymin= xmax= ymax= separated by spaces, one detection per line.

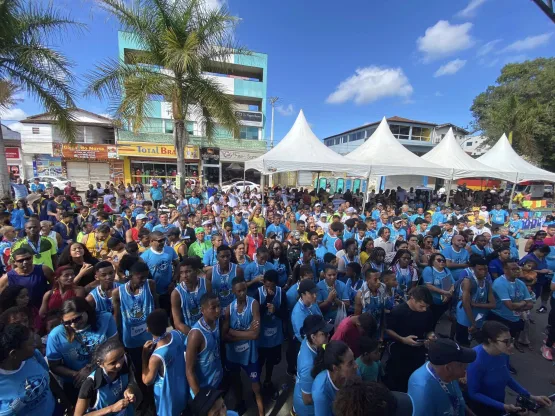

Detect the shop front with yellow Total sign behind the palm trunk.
xmin=118 ymin=143 xmax=199 ymax=185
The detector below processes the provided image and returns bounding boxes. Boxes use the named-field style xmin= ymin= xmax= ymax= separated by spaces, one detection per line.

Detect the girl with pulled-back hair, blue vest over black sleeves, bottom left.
xmin=74 ymin=338 xmax=139 ymax=416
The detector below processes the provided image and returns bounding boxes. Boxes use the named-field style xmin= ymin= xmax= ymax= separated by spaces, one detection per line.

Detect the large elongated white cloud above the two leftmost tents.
xmin=326 ymin=66 xmax=413 ymax=104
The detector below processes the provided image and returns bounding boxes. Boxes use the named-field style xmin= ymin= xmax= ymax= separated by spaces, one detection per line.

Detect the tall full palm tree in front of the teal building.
xmin=87 ymin=0 xmax=249 ymax=191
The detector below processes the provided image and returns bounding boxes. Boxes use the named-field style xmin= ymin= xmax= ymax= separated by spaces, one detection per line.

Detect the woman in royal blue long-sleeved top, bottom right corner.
xmin=466 ymin=321 xmax=551 ymax=416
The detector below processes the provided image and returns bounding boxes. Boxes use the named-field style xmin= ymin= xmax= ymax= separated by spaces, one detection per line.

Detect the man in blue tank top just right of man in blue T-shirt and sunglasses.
xmin=171 ymin=257 xmax=212 ymax=335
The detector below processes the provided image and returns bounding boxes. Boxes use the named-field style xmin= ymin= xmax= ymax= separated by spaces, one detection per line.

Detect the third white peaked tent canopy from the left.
xmin=422 ymin=128 xmax=514 ymax=180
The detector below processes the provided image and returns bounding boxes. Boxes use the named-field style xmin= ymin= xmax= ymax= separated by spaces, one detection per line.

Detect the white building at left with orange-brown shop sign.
xmin=21 ymin=108 xmax=119 ymax=191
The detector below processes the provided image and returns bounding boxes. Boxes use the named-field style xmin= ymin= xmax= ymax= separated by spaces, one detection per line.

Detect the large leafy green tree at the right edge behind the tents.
xmin=470 ymin=58 xmax=555 ymax=171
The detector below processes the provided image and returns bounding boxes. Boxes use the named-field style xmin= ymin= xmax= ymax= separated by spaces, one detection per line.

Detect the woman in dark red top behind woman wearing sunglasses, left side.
xmin=39 ymin=264 xmax=86 ymax=319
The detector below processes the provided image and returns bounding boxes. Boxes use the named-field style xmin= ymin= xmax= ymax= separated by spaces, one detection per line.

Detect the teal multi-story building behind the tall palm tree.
xmin=117 ymin=32 xmax=268 ymax=188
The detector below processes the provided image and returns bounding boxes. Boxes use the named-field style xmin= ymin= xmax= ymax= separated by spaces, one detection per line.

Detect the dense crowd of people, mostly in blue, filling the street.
xmin=0 ymin=180 xmax=555 ymax=416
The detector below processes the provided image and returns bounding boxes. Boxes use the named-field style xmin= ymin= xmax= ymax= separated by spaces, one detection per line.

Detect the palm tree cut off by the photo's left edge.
xmin=0 ymin=0 xmax=81 ymax=196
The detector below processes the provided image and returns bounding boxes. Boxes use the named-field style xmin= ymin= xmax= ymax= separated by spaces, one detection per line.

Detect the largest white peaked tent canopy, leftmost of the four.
xmin=245 ymin=110 xmax=368 ymax=176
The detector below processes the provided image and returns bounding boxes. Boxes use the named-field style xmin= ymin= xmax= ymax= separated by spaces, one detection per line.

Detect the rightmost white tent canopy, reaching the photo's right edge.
xmin=477 ymin=134 xmax=555 ymax=183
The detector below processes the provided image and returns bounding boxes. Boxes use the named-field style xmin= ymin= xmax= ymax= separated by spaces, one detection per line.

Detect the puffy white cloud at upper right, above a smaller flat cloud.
xmin=416 ymin=20 xmax=474 ymax=62
